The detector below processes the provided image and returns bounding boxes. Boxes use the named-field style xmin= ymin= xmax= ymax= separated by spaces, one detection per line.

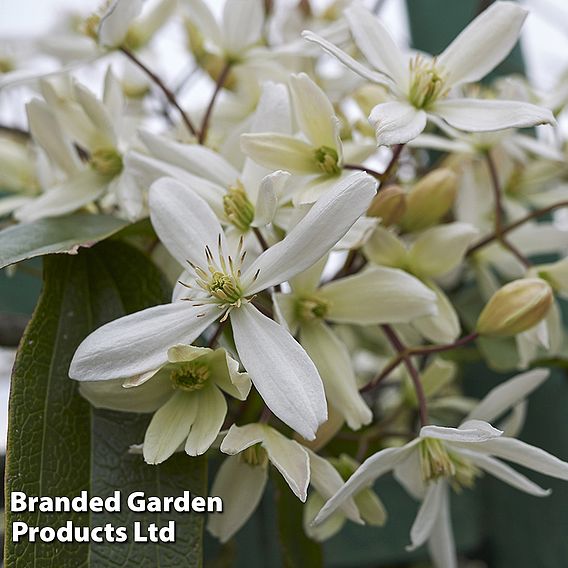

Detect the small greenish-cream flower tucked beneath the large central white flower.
xmin=79 ymin=345 xmax=251 ymax=464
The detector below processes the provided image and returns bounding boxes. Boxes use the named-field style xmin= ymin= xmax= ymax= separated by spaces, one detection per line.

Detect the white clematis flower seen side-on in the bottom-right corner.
xmin=315 ymin=369 xmax=568 ymax=568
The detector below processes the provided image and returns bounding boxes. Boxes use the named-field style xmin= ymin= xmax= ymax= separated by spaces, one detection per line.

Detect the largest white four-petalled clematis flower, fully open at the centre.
xmin=70 ymin=174 xmax=377 ymax=439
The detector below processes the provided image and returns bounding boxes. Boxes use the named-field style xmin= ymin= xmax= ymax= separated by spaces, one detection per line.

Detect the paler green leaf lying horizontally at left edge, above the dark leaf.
xmin=0 ymin=213 xmax=128 ymax=268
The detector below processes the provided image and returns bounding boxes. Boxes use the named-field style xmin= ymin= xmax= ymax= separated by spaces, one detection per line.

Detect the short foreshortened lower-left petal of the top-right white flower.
xmin=369 ymin=101 xmax=427 ymax=146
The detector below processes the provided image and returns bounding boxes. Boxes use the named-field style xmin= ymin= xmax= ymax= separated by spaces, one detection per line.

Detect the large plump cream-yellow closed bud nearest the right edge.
xmin=476 ymin=278 xmax=553 ymax=337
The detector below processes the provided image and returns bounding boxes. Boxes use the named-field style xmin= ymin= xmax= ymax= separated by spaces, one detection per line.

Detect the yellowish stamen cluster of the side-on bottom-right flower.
xmin=420 ymin=438 xmax=481 ymax=490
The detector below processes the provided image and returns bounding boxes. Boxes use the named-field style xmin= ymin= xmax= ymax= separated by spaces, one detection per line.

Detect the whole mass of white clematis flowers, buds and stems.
xmin=0 ymin=0 xmax=568 ymax=568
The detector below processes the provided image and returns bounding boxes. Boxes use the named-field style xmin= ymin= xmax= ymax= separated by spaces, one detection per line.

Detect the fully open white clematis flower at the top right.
xmin=303 ymin=2 xmax=555 ymax=145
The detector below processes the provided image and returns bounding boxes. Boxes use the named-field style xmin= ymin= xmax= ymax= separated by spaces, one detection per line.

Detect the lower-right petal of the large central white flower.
xmin=230 ymin=304 xmax=327 ymax=440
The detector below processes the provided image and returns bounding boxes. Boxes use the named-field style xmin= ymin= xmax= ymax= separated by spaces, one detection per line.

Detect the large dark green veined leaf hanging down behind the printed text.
xmin=5 ymin=241 xmax=206 ymax=568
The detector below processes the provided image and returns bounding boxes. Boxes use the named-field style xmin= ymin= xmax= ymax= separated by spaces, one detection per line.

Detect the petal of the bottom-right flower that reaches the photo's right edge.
xmin=476 ymin=437 xmax=568 ymax=481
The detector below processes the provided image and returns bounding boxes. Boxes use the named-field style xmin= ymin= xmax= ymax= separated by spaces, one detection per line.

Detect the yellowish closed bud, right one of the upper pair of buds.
xmin=401 ymin=168 xmax=458 ymax=232
